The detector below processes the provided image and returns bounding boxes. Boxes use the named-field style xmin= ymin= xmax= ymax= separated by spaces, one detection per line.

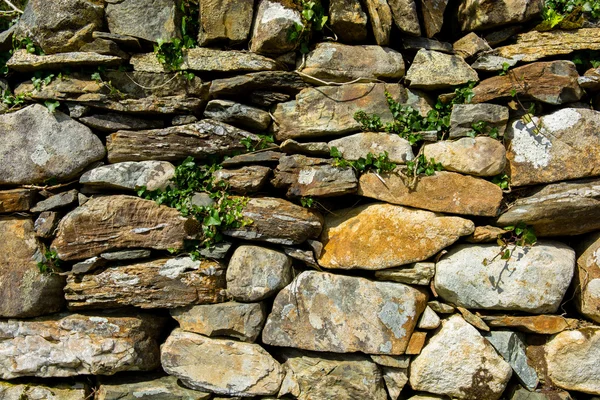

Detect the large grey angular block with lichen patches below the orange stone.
xmin=262 ymin=271 xmax=427 ymax=354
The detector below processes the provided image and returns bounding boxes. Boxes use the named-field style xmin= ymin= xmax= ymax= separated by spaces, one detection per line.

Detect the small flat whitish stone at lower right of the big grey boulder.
xmin=79 ymin=161 xmax=175 ymax=194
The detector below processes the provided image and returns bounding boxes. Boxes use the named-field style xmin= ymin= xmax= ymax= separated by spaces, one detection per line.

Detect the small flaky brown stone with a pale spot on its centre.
xmin=271 ymin=154 xmax=358 ymax=197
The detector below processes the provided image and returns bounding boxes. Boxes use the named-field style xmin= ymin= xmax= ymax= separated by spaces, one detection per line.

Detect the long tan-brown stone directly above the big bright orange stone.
xmin=358 ymin=171 xmax=502 ymax=217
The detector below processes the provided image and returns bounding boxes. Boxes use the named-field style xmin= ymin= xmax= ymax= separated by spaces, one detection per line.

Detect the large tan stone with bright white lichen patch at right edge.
xmin=506 ymin=108 xmax=600 ymax=187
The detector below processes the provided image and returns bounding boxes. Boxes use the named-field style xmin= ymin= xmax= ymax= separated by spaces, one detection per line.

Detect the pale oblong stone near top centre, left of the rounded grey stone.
xmin=300 ymin=42 xmax=404 ymax=82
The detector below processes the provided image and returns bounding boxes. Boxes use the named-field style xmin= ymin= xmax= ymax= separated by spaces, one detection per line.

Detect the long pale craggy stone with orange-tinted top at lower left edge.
xmin=0 ymin=314 xmax=164 ymax=379
